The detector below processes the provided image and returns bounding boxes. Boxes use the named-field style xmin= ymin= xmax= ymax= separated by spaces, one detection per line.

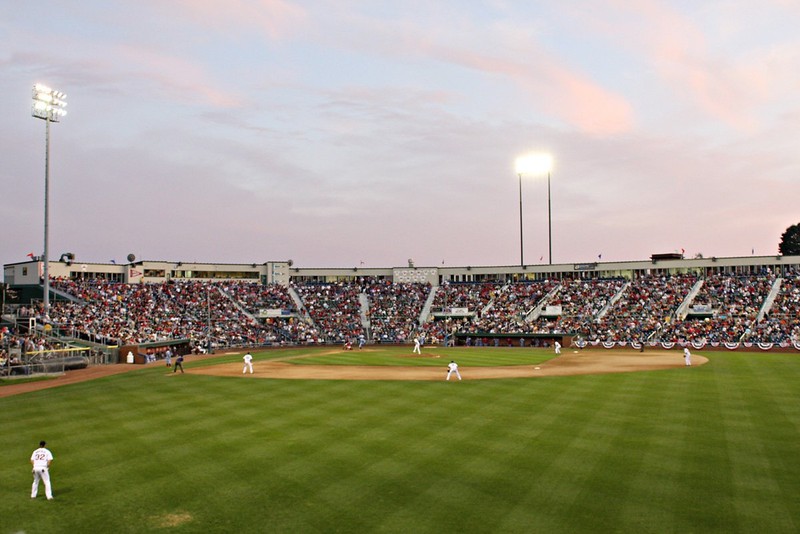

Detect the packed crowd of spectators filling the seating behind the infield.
xmin=6 ymin=272 xmax=800 ymax=347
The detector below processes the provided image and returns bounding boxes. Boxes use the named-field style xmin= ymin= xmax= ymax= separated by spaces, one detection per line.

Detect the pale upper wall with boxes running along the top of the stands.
xmin=3 ymin=255 xmax=800 ymax=292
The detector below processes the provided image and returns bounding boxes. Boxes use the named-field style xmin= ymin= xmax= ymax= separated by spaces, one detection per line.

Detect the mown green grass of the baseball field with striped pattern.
xmin=0 ymin=348 xmax=800 ymax=534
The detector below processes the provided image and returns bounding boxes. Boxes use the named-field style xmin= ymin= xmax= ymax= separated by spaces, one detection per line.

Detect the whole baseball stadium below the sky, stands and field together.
xmin=0 ymin=253 xmax=800 ymax=532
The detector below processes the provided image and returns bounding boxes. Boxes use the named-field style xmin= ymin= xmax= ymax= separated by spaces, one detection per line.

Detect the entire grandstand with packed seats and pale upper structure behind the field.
xmin=0 ymin=255 xmax=800 ymax=362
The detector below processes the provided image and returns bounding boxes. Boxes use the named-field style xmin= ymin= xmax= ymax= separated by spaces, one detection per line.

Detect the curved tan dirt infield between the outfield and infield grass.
xmin=186 ymin=350 xmax=708 ymax=380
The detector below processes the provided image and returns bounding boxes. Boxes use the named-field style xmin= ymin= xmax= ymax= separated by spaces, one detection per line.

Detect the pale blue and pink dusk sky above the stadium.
xmin=0 ymin=0 xmax=800 ymax=267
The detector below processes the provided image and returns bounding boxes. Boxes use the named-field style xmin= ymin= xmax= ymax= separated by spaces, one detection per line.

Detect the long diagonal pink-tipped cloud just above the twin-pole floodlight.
xmin=324 ymin=10 xmax=635 ymax=135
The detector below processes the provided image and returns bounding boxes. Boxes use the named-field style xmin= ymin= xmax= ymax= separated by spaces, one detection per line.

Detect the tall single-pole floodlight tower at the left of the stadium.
xmin=31 ymin=83 xmax=67 ymax=317
